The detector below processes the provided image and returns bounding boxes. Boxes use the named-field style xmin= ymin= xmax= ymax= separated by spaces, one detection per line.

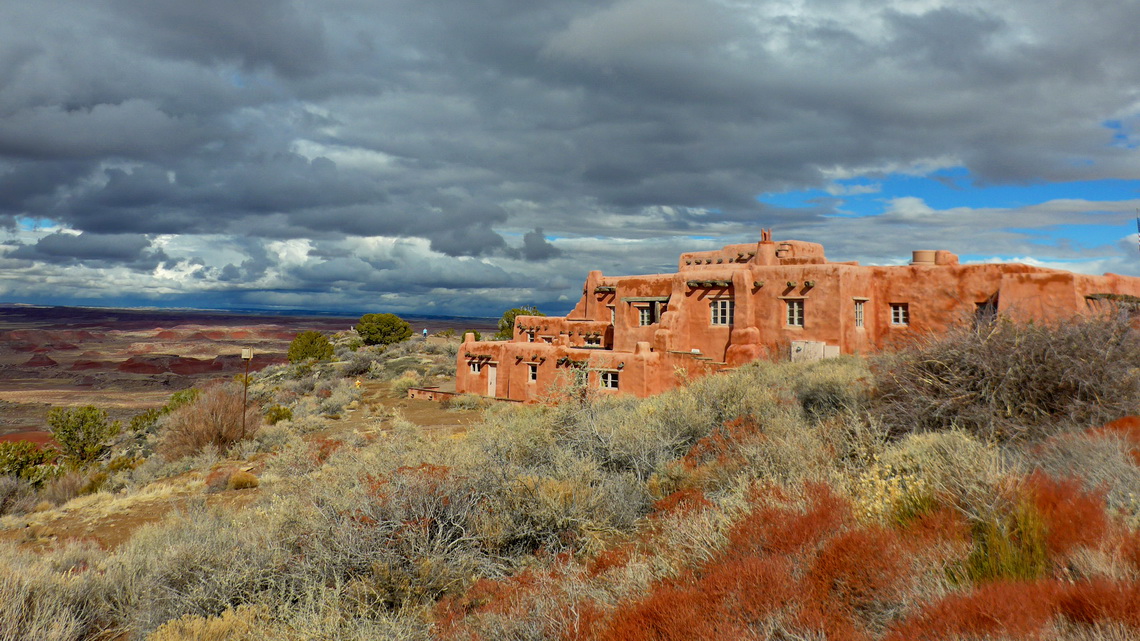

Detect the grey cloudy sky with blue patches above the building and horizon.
xmin=0 ymin=0 xmax=1140 ymax=316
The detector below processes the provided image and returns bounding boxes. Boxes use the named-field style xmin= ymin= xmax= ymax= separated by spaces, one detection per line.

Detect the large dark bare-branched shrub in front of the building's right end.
xmin=876 ymin=317 xmax=1140 ymax=441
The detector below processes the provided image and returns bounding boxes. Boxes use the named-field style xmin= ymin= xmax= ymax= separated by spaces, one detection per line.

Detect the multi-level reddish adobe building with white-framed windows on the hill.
xmin=456 ymin=230 xmax=1140 ymax=401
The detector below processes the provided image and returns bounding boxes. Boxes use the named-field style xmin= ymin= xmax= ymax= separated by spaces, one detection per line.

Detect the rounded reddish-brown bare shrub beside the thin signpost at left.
xmin=157 ymin=384 xmax=261 ymax=460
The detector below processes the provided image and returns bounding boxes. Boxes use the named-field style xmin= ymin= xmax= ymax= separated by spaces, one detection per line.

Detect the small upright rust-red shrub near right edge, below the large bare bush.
xmin=1025 ymin=472 xmax=1108 ymax=558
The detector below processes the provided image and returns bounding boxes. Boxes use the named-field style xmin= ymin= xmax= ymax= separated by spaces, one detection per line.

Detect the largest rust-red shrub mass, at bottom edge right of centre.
xmin=597 ymin=485 xmax=909 ymax=641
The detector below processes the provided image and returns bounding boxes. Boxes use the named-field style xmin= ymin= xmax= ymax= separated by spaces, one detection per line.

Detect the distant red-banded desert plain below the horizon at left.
xmin=0 ymin=305 xmax=494 ymax=441
